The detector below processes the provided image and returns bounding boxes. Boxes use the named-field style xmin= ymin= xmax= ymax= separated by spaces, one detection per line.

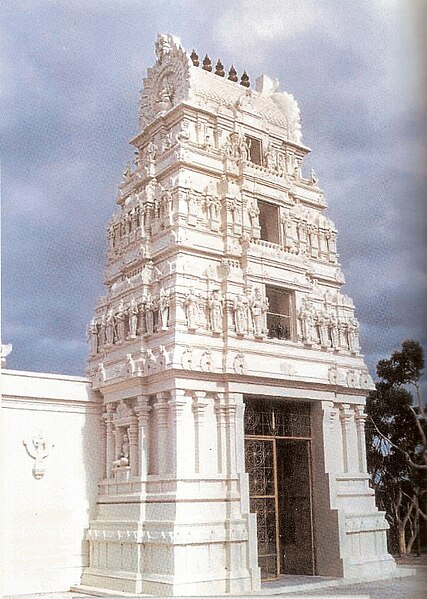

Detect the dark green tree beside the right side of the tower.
xmin=366 ymin=340 xmax=427 ymax=554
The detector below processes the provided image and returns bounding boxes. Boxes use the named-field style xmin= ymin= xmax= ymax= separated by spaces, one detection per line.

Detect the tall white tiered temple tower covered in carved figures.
xmin=82 ymin=35 xmax=394 ymax=595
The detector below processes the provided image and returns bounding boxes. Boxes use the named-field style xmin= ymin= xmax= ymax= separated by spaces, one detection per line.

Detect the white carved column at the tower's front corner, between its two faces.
xmin=168 ymin=389 xmax=191 ymax=478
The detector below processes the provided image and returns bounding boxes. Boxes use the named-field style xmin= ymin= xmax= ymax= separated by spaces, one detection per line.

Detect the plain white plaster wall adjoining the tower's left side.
xmin=1 ymin=369 xmax=103 ymax=595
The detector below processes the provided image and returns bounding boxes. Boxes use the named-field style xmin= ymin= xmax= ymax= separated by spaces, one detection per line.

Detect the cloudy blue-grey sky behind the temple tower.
xmin=0 ymin=0 xmax=427 ymax=382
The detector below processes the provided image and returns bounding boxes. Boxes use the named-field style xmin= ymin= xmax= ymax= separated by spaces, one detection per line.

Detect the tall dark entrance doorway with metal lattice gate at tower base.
xmin=245 ymin=398 xmax=315 ymax=580
